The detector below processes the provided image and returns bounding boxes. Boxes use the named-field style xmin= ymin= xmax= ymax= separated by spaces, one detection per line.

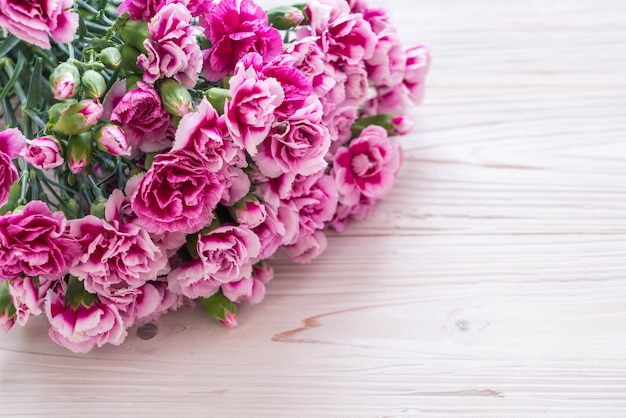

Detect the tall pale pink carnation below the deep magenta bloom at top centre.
xmin=225 ymin=54 xmax=285 ymax=155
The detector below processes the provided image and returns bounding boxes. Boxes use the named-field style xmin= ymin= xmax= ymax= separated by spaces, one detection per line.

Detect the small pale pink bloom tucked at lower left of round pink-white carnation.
xmin=167 ymin=259 xmax=222 ymax=299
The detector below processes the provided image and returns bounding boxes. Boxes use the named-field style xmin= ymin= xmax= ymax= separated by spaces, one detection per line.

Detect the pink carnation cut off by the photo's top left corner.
xmin=0 ymin=0 xmax=78 ymax=49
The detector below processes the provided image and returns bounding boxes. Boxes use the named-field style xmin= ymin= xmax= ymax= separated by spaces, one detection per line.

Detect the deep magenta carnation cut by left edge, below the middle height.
xmin=0 ymin=200 xmax=79 ymax=280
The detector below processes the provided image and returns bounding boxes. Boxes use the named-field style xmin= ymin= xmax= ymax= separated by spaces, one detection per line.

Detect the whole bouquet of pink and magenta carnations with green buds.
xmin=0 ymin=0 xmax=430 ymax=352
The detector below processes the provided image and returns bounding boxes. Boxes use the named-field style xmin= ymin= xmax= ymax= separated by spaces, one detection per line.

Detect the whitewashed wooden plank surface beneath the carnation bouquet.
xmin=0 ymin=0 xmax=626 ymax=417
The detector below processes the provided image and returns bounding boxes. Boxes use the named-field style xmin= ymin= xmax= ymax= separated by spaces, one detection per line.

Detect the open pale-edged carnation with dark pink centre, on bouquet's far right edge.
xmin=332 ymin=125 xmax=402 ymax=205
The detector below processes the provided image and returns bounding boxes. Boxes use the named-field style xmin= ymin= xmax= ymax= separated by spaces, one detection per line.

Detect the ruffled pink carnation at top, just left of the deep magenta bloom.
xmin=137 ymin=3 xmax=202 ymax=88
